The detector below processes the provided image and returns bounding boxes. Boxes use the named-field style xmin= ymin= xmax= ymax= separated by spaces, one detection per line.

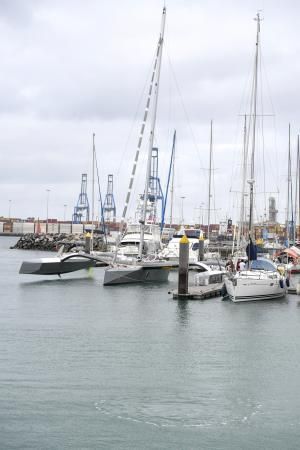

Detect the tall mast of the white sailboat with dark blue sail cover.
xmin=248 ymin=13 xmax=261 ymax=238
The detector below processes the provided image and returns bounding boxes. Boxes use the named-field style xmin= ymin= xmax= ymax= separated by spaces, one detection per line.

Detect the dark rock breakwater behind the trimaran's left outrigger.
xmin=11 ymin=233 xmax=106 ymax=253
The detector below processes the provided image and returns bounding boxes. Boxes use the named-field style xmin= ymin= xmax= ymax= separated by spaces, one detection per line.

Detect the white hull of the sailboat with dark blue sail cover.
xmin=225 ymin=271 xmax=287 ymax=302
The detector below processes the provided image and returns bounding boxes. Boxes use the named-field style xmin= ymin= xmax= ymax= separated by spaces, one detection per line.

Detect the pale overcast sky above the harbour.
xmin=0 ymin=0 xmax=300 ymax=222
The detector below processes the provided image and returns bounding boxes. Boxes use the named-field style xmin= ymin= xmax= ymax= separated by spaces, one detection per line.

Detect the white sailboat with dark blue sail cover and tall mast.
xmin=225 ymin=13 xmax=287 ymax=302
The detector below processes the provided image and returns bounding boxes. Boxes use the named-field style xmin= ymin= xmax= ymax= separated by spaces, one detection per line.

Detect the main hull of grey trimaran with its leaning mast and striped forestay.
xmin=103 ymin=7 xmax=170 ymax=285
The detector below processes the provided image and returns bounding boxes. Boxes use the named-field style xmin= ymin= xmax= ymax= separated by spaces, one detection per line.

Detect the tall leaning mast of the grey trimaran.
xmin=139 ymin=7 xmax=166 ymax=258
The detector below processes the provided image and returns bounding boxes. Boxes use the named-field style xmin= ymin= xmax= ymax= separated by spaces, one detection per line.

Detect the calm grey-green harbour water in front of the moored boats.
xmin=0 ymin=237 xmax=300 ymax=450
